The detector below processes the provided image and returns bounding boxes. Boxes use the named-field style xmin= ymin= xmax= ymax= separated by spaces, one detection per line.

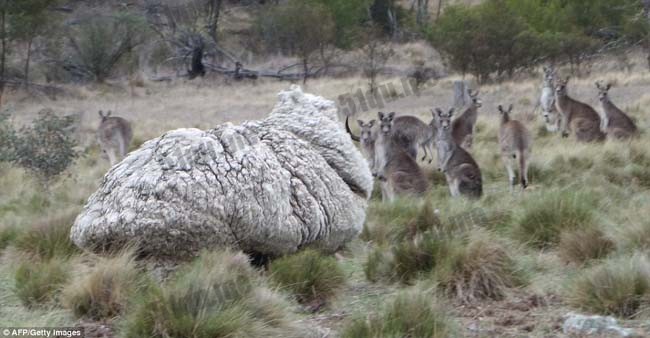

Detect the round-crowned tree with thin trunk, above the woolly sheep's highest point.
xmin=258 ymin=0 xmax=336 ymax=83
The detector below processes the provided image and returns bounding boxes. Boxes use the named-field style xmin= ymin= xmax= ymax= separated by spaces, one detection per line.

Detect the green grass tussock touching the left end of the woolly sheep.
xmin=16 ymin=211 xmax=79 ymax=259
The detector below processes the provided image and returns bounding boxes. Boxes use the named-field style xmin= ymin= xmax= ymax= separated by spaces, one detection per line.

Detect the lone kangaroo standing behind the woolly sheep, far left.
xmin=97 ymin=110 xmax=133 ymax=166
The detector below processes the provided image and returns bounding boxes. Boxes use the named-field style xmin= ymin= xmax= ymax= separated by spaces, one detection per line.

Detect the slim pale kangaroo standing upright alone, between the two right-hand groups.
xmin=499 ymin=105 xmax=532 ymax=190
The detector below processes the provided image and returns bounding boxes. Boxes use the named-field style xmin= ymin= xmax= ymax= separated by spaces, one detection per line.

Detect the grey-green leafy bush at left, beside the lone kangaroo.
xmin=15 ymin=109 xmax=79 ymax=188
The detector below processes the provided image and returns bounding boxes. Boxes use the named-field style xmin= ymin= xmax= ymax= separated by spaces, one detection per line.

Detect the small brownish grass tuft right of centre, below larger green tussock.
xmin=558 ymin=227 xmax=615 ymax=264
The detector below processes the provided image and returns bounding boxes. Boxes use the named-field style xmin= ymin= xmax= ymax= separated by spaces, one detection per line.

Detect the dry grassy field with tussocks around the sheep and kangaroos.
xmin=0 ymin=52 xmax=650 ymax=337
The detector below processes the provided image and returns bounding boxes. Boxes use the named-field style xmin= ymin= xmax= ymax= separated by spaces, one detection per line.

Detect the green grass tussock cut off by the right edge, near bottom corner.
xmin=567 ymin=255 xmax=650 ymax=318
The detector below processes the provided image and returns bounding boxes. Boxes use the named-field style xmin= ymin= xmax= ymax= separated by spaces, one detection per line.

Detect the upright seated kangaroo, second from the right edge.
xmin=555 ymin=77 xmax=605 ymax=142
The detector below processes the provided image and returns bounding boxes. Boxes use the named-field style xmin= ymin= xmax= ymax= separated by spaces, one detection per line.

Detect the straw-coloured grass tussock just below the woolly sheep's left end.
xmin=61 ymin=252 xmax=144 ymax=320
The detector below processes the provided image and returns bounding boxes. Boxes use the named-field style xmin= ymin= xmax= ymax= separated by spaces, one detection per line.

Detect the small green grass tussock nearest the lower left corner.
xmin=14 ymin=259 xmax=70 ymax=307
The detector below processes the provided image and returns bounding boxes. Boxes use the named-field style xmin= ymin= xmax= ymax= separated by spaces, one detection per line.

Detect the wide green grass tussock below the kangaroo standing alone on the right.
xmin=513 ymin=190 xmax=597 ymax=248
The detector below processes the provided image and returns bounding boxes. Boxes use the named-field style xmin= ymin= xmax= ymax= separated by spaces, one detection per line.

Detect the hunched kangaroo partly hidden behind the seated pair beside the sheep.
xmin=393 ymin=115 xmax=433 ymax=163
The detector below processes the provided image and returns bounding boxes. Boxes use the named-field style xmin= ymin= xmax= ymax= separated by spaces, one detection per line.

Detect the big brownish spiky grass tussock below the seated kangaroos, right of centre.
xmin=433 ymin=231 xmax=524 ymax=302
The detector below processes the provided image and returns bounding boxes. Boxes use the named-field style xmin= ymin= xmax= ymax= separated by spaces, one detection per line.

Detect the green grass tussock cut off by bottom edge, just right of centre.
xmin=341 ymin=290 xmax=455 ymax=338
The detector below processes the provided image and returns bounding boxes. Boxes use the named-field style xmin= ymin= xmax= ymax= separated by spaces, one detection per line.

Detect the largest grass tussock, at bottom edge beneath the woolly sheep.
xmin=121 ymin=252 xmax=303 ymax=337
